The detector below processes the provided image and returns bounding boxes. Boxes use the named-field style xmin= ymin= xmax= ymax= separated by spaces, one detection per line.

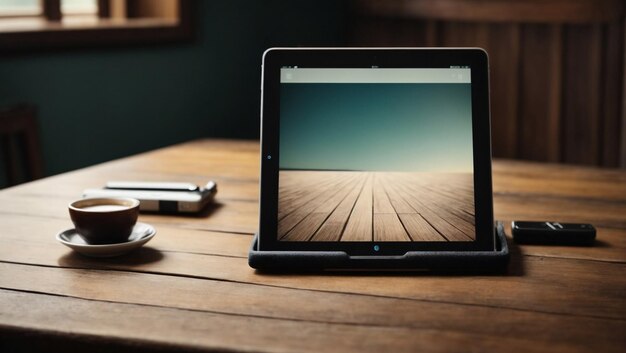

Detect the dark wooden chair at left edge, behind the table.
xmin=0 ymin=105 xmax=43 ymax=186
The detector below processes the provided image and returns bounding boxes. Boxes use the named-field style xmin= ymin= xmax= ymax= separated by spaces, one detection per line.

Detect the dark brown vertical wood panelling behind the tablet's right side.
xmin=350 ymin=0 xmax=626 ymax=168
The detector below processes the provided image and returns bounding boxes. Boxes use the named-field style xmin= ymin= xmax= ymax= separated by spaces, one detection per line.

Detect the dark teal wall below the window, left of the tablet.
xmin=0 ymin=0 xmax=345 ymax=182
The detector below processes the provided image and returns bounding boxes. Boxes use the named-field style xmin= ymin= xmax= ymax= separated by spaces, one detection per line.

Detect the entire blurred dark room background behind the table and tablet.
xmin=0 ymin=0 xmax=626 ymax=188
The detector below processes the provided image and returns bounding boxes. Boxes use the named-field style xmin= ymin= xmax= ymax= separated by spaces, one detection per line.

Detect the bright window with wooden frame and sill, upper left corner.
xmin=0 ymin=0 xmax=192 ymax=51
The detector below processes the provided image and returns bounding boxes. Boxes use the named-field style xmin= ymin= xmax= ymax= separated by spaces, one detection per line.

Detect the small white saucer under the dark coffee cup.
xmin=57 ymin=222 xmax=156 ymax=257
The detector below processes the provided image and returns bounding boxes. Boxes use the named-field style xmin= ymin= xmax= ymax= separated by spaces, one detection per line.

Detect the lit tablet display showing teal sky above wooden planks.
xmin=277 ymin=66 xmax=476 ymax=243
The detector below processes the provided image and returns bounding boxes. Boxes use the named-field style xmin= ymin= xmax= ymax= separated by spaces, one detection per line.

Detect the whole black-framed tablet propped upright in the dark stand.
xmin=257 ymin=48 xmax=496 ymax=257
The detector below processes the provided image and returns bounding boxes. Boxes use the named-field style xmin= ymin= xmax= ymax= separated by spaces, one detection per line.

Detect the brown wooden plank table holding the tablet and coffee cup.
xmin=0 ymin=140 xmax=626 ymax=352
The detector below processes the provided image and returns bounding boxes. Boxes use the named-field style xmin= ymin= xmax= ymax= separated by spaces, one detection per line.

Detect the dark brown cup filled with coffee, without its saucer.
xmin=69 ymin=198 xmax=139 ymax=244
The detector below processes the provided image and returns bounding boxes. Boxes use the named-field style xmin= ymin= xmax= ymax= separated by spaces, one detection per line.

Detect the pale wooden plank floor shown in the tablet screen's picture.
xmin=278 ymin=171 xmax=476 ymax=241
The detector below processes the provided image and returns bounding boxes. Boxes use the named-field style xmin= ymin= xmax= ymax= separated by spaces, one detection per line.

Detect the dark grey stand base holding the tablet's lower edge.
xmin=248 ymin=221 xmax=509 ymax=273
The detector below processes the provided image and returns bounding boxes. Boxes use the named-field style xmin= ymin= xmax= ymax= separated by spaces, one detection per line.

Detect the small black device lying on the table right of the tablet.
xmin=511 ymin=221 xmax=596 ymax=245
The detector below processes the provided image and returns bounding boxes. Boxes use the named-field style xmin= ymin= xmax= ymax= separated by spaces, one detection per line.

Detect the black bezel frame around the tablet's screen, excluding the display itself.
xmin=259 ymin=48 xmax=495 ymax=256
